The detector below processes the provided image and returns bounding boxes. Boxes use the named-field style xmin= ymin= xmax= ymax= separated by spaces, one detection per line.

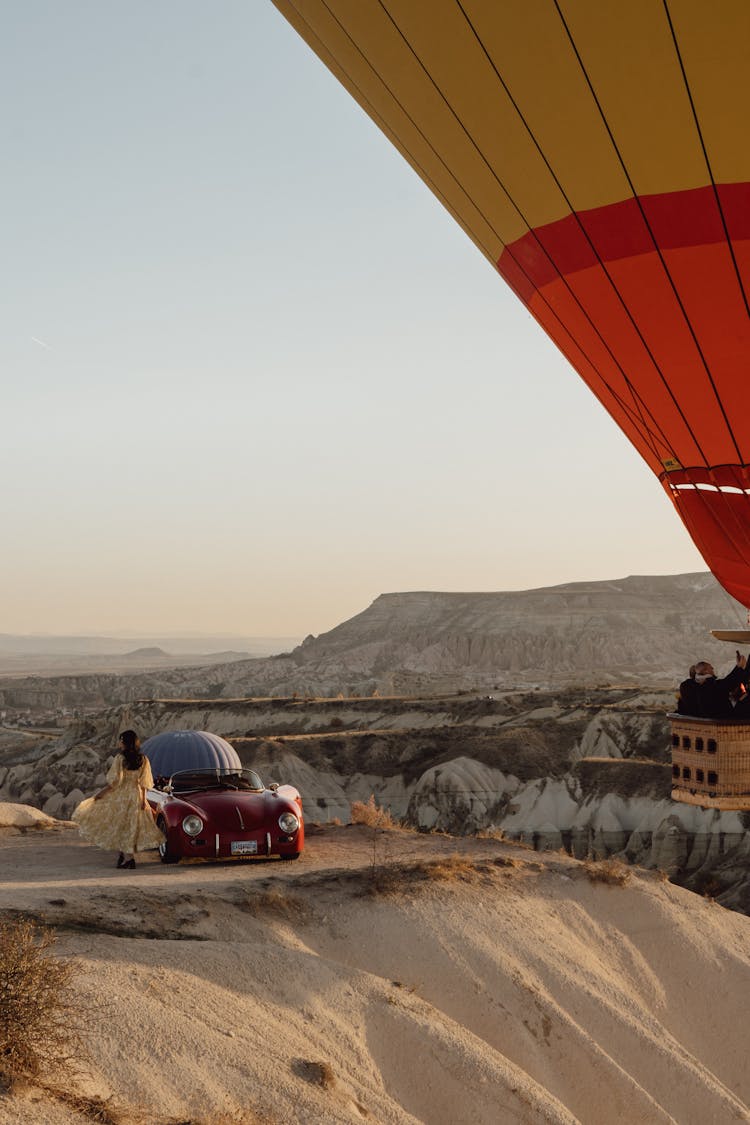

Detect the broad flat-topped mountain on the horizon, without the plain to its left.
xmin=278 ymin=573 xmax=747 ymax=690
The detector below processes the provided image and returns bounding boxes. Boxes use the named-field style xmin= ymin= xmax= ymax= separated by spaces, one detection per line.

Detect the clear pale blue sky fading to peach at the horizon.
xmin=0 ymin=0 xmax=705 ymax=636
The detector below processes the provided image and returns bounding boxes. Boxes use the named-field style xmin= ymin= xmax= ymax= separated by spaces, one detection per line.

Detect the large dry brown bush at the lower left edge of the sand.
xmin=0 ymin=919 xmax=82 ymax=1090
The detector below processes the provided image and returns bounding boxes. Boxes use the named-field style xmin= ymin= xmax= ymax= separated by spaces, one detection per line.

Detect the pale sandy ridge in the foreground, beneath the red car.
xmin=0 ymin=827 xmax=750 ymax=1125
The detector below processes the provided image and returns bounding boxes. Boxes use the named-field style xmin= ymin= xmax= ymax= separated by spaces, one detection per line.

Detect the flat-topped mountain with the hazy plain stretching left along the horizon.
xmin=0 ymin=573 xmax=747 ymax=707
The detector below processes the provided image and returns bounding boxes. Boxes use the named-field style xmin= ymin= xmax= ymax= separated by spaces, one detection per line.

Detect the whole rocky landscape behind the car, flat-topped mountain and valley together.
xmin=0 ymin=574 xmax=750 ymax=911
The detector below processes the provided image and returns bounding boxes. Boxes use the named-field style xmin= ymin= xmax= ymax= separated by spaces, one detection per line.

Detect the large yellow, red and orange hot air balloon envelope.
xmin=274 ymin=0 xmax=750 ymax=807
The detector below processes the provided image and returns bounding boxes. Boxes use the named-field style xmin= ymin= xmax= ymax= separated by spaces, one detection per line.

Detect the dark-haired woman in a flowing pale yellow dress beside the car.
xmin=72 ymin=730 xmax=164 ymax=867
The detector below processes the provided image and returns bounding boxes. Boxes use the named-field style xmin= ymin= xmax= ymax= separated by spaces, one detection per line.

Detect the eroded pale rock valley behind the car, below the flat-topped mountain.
xmin=0 ymin=689 xmax=750 ymax=910
